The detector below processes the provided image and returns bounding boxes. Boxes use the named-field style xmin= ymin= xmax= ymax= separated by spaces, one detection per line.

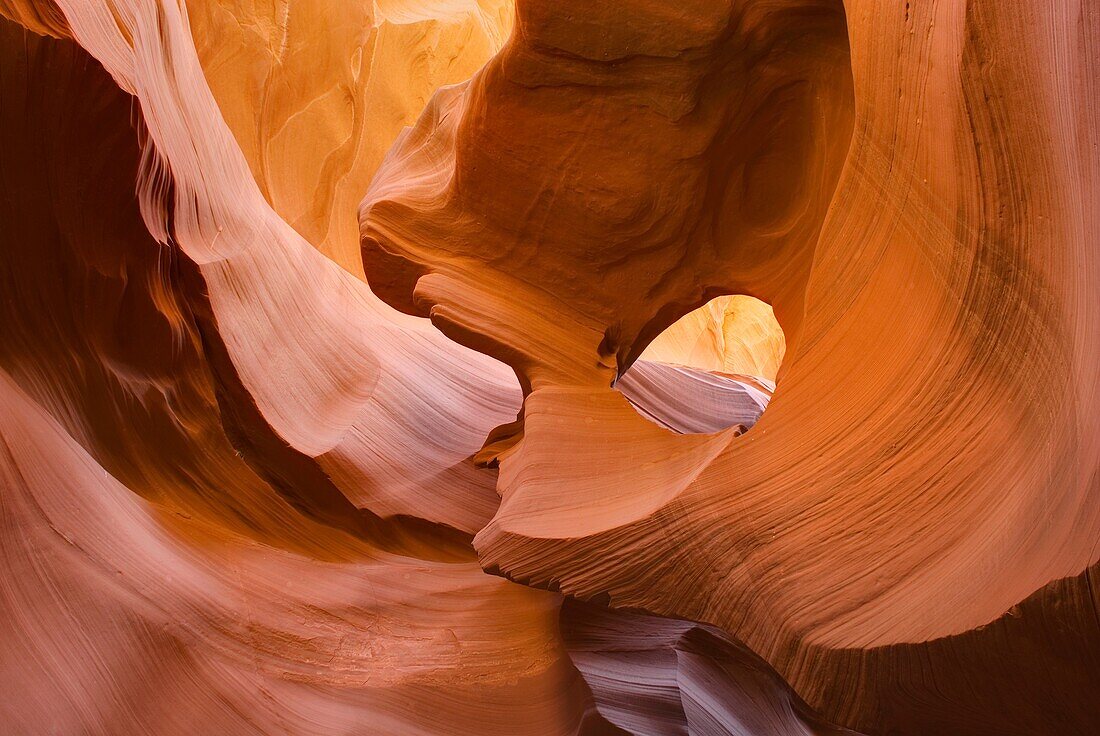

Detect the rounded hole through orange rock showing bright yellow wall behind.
xmin=616 ymin=295 xmax=787 ymax=435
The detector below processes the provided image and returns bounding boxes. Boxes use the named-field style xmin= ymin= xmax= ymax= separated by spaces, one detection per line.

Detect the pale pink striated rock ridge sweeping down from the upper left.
xmin=49 ymin=2 xmax=518 ymax=532
